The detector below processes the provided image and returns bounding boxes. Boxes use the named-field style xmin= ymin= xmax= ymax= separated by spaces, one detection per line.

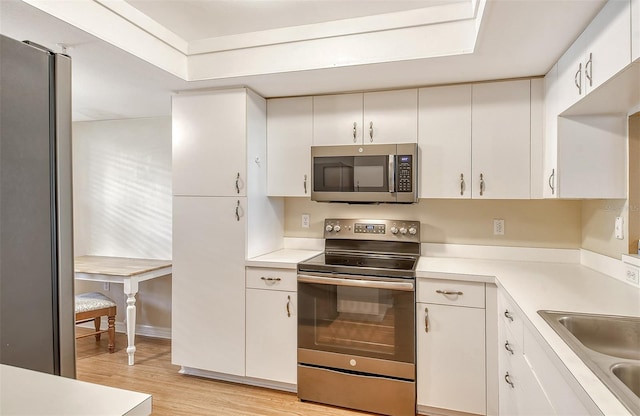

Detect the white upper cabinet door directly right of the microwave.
xmin=418 ymin=84 xmax=471 ymax=198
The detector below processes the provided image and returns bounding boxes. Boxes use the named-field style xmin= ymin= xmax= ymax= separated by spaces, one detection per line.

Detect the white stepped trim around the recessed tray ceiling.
xmin=24 ymin=0 xmax=485 ymax=81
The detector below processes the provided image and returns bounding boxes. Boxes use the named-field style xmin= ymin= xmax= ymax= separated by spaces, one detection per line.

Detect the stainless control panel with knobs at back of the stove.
xmin=324 ymin=218 xmax=420 ymax=242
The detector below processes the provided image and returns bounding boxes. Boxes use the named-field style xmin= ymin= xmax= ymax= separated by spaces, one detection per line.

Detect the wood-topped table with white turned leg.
xmin=75 ymin=256 xmax=172 ymax=365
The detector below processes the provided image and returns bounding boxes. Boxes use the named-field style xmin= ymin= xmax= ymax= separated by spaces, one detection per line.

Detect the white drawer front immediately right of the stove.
xmin=417 ymin=279 xmax=484 ymax=308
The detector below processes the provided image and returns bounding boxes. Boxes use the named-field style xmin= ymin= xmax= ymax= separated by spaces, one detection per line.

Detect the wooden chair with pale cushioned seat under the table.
xmin=76 ymin=292 xmax=116 ymax=353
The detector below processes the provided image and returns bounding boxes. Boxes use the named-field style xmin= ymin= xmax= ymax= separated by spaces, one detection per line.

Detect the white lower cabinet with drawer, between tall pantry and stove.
xmin=246 ymin=267 xmax=298 ymax=385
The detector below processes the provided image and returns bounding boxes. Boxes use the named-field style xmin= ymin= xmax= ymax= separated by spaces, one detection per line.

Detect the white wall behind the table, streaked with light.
xmin=73 ymin=117 xmax=172 ymax=331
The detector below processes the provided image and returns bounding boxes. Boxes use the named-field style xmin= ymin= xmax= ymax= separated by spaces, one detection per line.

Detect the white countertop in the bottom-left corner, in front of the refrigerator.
xmin=0 ymin=364 xmax=151 ymax=416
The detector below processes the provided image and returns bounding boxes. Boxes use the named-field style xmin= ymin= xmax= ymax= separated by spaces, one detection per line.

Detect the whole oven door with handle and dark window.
xmin=298 ymin=274 xmax=415 ymax=379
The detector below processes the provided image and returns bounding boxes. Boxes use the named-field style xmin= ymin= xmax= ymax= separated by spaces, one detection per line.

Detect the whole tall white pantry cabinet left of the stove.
xmin=172 ymin=88 xmax=283 ymax=376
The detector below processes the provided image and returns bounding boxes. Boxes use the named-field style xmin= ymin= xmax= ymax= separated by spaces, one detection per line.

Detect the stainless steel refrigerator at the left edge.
xmin=0 ymin=35 xmax=75 ymax=378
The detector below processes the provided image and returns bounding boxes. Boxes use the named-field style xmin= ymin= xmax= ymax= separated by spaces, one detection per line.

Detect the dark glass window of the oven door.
xmin=298 ymin=282 xmax=415 ymax=363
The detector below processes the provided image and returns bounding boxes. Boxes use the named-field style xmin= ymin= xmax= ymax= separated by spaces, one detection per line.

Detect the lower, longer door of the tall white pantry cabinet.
xmin=172 ymin=197 xmax=246 ymax=376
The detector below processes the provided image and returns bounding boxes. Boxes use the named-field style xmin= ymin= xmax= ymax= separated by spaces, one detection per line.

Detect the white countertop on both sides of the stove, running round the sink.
xmin=247 ymin=249 xmax=640 ymax=416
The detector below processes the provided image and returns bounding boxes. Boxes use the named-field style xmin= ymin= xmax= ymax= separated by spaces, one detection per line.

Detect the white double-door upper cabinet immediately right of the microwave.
xmin=418 ymin=79 xmax=542 ymax=199
